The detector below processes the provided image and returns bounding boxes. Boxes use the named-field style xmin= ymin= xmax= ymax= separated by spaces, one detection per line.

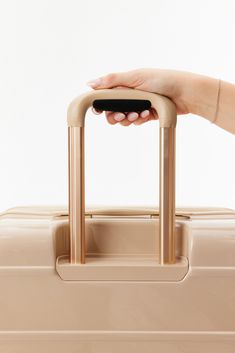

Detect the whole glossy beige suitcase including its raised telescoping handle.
xmin=0 ymin=89 xmax=235 ymax=353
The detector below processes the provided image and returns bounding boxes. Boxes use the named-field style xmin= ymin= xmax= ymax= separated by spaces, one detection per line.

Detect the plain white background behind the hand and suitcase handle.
xmin=0 ymin=0 xmax=235 ymax=211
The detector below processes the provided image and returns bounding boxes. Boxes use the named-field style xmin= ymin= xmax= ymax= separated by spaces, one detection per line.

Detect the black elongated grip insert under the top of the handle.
xmin=92 ymin=99 xmax=151 ymax=112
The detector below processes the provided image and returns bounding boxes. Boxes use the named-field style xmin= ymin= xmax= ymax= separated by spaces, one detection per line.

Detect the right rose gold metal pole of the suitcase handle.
xmin=159 ymin=127 xmax=175 ymax=265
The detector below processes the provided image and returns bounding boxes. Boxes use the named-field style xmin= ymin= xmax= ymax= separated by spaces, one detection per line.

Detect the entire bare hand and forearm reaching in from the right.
xmin=88 ymin=69 xmax=235 ymax=134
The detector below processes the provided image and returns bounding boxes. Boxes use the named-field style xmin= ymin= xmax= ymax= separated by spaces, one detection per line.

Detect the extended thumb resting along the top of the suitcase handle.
xmin=87 ymin=71 xmax=138 ymax=89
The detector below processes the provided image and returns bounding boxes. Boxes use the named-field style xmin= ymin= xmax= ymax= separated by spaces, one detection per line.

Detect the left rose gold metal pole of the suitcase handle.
xmin=68 ymin=127 xmax=85 ymax=264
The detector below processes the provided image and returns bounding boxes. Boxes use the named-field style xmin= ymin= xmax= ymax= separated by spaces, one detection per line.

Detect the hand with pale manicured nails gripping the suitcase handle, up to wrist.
xmin=88 ymin=69 xmax=190 ymax=126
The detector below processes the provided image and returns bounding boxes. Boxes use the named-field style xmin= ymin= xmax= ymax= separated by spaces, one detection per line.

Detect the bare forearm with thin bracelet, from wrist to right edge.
xmin=182 ymin=73 xmax=235 ymax=134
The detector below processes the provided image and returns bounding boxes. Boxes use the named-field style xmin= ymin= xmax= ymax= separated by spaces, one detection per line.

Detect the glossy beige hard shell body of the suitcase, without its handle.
xmin=0 ymin=207 xmax=235 ymax=353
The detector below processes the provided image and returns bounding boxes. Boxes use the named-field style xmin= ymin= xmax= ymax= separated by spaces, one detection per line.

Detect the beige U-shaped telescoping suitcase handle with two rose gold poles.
xmin=67 ymin=88 xmax=177 ymax=264
